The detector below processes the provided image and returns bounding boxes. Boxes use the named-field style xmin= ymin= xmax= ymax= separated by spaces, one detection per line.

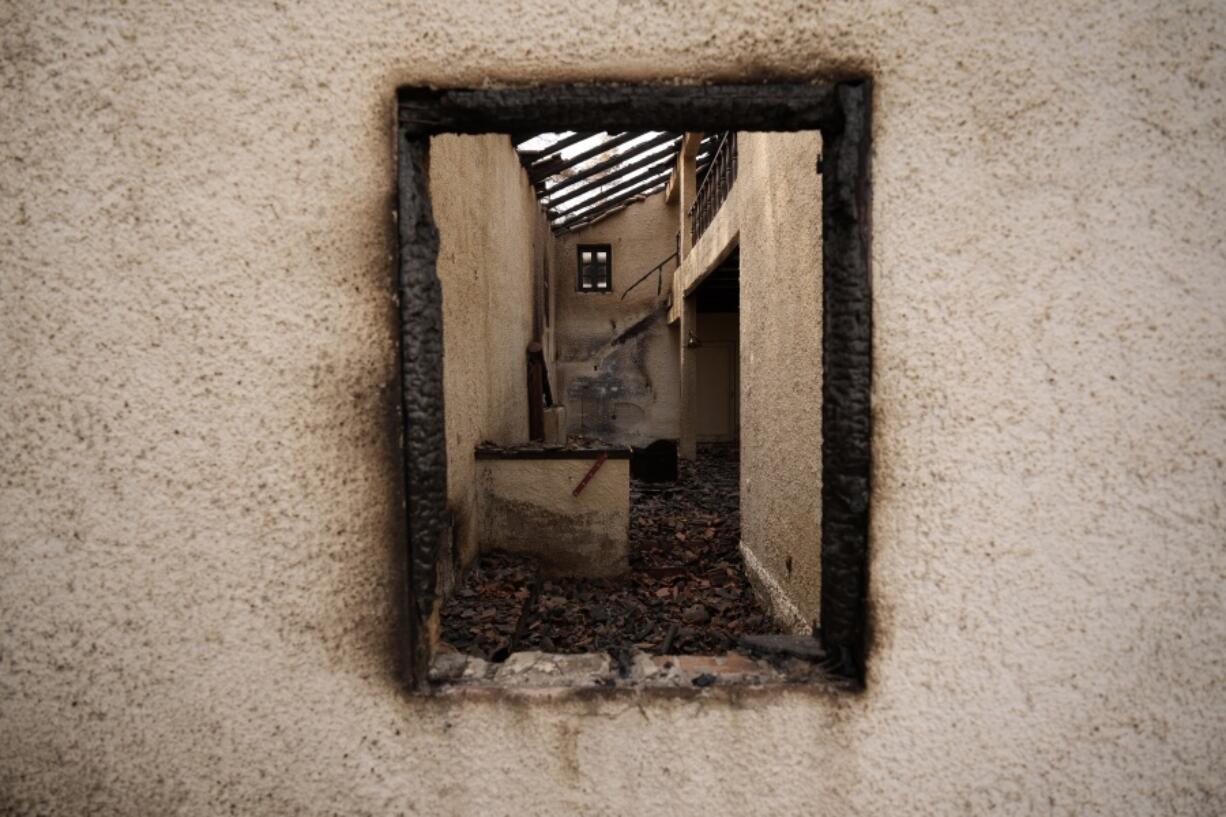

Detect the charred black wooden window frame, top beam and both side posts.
xmin=396 ymin=80 xmax=872 ymax=689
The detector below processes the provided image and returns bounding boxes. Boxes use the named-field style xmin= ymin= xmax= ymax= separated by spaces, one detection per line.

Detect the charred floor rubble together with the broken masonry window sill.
xmin=434 ymin=445 xmax=820 ymax=686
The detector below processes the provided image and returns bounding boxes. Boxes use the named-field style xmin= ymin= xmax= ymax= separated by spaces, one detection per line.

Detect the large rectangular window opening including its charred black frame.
xmin=396 ymin=80 xmax=872 ymax=694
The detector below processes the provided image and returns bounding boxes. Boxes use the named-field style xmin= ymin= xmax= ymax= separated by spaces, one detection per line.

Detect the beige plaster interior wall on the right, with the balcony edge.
xmin=673 ymin=131 xmax=821 ymax=632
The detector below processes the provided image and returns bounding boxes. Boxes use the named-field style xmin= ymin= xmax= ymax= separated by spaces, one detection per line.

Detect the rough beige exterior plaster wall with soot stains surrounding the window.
xmin=0 ymin=0 xmax=1226 ymax=816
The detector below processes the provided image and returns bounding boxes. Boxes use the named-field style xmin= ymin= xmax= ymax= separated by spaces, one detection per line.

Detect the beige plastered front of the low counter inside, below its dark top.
xmin=477 ymin=458 xmax=630 ymax=577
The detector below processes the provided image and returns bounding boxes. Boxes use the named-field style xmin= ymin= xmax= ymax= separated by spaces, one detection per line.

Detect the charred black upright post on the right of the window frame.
xmin=820 ymin=80 xmax=873 ymax=682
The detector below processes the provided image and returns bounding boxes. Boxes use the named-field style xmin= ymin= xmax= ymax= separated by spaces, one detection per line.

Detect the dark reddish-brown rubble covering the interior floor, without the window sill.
xmin=443 ymin=445 xmax=772 ymax=661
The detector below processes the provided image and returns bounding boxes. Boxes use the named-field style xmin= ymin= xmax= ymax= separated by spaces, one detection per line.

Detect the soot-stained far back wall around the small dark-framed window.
xmin=553 ymin=193 xmax=680 ymax=445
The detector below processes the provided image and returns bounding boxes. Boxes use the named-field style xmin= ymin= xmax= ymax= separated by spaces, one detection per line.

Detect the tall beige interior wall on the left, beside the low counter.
xmin=430 ymin=135 xmax=549 ymax=569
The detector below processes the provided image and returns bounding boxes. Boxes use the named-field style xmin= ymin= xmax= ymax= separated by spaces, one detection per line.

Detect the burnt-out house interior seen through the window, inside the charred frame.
xmin=429 ymin=131 xmax=829 ymax=686
